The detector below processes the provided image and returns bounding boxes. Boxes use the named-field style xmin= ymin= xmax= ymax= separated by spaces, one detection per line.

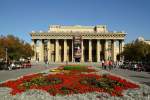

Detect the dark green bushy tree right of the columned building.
xmin=122 ymin=41 xmax=150 ymax=61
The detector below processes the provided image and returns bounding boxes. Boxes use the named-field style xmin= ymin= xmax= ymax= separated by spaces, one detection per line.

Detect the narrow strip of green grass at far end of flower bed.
xmin=64 ymin=65 xmax=87 ymax=70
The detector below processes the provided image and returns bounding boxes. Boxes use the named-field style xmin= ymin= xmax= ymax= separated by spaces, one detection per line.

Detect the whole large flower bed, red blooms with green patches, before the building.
xmin=0 ymin=67 xmax=139 ymax=96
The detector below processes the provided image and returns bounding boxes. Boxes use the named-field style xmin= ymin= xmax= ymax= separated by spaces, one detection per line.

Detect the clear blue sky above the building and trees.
xmin=0 ymin=0 xmax=150 ymax=42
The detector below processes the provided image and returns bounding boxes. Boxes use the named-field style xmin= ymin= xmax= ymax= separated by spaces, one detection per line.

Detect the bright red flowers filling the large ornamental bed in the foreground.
xmin=0 ymin=66 xmax=139 ymax=96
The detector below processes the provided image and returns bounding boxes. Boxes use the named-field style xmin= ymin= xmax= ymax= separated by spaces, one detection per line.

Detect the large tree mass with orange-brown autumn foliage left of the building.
xmin=0 ymin=35 xmax=34 ymax=60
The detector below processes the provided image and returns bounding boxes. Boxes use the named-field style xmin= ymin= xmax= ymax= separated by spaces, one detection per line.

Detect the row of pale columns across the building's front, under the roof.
xmin=32 ymin=39 xmax=124 ymax=62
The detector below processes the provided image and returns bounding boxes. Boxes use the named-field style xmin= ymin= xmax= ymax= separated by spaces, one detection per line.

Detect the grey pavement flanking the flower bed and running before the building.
xmin=0 ymin=63 xmax=150 ymax=86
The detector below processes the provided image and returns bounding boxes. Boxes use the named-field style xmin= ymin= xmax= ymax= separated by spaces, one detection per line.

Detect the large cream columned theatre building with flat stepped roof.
xmin=30 ymin=25 xmax=126 ymax=62
